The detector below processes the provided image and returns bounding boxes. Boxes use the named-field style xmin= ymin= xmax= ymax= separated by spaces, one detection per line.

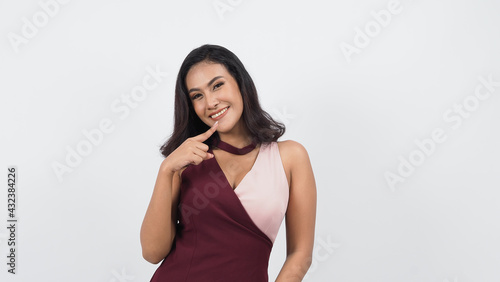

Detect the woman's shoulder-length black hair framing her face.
xmin=160 ymin=44 xmax=285 ymax=157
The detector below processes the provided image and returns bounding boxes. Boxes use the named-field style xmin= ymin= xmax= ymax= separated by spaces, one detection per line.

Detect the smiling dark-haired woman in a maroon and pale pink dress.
xmin=141 ymin=45 xmax=316 ymax=282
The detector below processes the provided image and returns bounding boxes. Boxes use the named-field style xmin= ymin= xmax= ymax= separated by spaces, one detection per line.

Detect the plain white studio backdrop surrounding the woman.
xmin=0 ymin=0 xmax=500 ymax=282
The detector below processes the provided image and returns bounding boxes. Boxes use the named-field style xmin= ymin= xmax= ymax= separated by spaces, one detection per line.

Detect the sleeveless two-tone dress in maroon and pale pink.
xmin=150 ymin=142 xmax=289 ymax=282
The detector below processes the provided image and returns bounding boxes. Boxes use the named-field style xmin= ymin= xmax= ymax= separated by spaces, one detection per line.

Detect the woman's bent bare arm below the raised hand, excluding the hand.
xmin=140 ymin=160 xmax=180 ymax=264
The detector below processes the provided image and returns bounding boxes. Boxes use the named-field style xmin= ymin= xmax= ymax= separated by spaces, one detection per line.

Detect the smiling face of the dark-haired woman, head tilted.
xmin=186 ymin=61 xmax=243 ymax=133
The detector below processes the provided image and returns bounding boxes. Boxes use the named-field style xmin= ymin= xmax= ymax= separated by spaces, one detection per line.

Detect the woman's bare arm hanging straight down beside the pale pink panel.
xmin=276 ymin=140 xmax=316 ymax=282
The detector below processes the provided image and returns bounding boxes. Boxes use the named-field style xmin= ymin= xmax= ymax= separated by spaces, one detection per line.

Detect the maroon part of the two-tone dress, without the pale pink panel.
xmin=151 ymin=140 xmax=282 ymax=282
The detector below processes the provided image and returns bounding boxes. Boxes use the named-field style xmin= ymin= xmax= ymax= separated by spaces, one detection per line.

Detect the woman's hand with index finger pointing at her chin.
xmin=162 ymin=121 xmax=219 ymax=173
